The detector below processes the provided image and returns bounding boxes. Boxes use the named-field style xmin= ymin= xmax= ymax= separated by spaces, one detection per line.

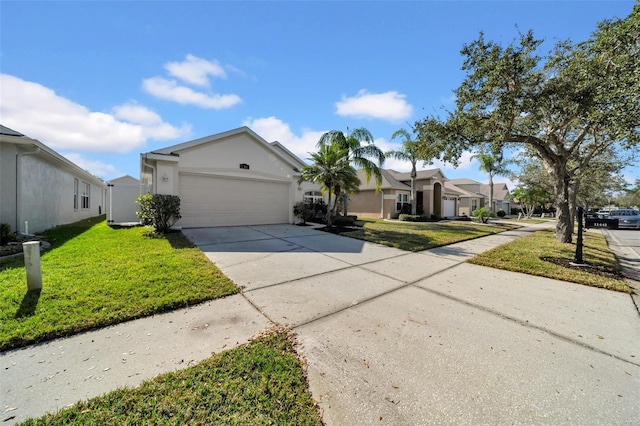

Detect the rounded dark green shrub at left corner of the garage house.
xmin=136 ymin=194 xmax=182 ymax=234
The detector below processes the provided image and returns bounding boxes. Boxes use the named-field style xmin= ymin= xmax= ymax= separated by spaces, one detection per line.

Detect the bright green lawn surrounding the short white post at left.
xmin=0 ymin=216 xmax=237 ymax=350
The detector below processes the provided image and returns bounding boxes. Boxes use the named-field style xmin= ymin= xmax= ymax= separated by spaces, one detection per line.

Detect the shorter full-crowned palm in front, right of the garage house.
xmin=299 ymin=144 xmax=360 ymax=227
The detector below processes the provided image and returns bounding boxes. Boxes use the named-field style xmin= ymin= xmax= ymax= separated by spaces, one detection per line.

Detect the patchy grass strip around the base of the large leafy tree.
xmin=468 ymin=230 xmax=631 ymax=293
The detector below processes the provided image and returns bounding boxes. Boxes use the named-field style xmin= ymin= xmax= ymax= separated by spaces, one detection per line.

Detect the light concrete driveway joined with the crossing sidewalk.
xmin=0 ymin=221 xmax=640 ymax=425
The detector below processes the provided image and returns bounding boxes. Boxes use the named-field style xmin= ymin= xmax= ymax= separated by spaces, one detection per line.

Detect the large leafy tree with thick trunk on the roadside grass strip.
xmin=418 ymin=4 xmax=640 ymax=243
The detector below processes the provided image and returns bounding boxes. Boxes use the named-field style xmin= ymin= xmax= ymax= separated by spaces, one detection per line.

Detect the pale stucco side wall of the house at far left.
xmin=13 ymin=151 xmax=105 ymax=233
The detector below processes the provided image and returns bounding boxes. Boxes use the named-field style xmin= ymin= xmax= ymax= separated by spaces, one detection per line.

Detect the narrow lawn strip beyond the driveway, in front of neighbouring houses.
xmin=340 ymin=219 xmax=517 ymax=251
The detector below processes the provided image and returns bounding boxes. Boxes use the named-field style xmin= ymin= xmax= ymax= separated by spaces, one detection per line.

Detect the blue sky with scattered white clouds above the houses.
xmin=0 ymin=0 xmax=640 ymax=186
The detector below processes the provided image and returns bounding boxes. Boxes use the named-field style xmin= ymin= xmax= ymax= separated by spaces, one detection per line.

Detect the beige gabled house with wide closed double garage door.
xmin=140 ymin=127 xmax=320 ymax=228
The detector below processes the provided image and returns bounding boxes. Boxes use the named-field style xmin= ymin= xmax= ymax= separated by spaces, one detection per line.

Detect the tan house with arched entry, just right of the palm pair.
xmin=348 ymin=169 xmax=458 ymax=219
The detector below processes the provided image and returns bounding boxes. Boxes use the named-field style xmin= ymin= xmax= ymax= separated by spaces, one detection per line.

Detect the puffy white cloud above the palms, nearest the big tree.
xmin=335 ymin=89 xmax=413 ymax=122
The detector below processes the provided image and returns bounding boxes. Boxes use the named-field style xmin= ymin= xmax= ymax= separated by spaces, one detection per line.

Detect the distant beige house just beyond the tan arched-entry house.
xmin=447 ymin=179 xmax=512 ymax=216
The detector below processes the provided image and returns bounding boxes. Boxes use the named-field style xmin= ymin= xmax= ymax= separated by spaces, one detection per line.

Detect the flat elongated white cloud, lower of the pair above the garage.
xmin=142 ymin=77 xmax=242 ymax=110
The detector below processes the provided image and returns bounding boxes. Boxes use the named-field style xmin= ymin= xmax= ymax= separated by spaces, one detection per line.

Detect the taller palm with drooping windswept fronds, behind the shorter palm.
xmin=317 ymin=127 xmax=384 ymax=216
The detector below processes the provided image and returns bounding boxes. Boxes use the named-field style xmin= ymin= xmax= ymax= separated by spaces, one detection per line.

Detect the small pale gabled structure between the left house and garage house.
xmin=106 ymin=175 xmax=141 ymax=225
